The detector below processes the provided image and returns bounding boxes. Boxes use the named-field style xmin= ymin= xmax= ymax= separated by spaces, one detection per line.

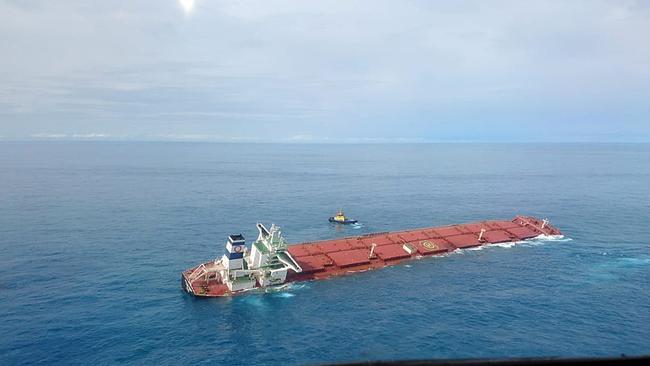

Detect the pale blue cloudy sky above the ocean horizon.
xmin=0 ymin=0 xmax=650 ymax=142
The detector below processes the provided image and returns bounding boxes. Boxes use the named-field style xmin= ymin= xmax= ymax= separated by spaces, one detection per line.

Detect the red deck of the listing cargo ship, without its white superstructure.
xmin=183 ymin=216 xmax=562 ymax=297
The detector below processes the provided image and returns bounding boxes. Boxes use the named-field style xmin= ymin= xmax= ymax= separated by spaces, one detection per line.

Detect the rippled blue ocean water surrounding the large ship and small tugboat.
xmin=0 ymin=142 xmax=650 ymax=365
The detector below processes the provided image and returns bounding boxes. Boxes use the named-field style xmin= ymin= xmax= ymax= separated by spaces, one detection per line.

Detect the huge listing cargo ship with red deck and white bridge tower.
xmin=181 ymin=216 xmax=562 ymax=297
